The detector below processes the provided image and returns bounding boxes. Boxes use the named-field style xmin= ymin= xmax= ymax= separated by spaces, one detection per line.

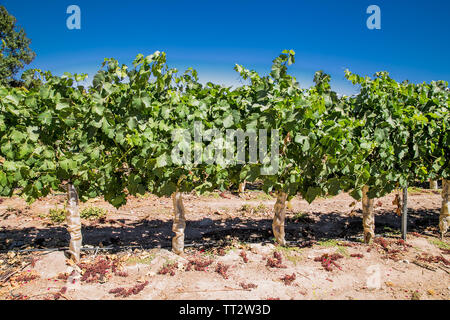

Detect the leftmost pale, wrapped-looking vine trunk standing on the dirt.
xmin=66 ymin=183 xmax=82 ymax=263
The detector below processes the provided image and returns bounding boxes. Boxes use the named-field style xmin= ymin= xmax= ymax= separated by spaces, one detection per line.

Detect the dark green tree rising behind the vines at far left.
xmin=0 ymin=6 xmax=36 ymax=86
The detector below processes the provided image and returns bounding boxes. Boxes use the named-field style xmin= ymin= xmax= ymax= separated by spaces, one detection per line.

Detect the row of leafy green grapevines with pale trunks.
xmin=0 ymin=50 xmax=450 ymax=261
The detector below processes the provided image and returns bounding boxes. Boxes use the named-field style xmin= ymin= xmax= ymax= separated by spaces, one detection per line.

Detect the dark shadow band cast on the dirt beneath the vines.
xmin=0 ymin=210 xmax=439 ymax=252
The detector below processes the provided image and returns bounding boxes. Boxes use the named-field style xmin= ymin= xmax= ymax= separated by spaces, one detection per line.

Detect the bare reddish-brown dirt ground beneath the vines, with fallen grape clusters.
xmin=0 ymin=190 xmax=450 ymax=300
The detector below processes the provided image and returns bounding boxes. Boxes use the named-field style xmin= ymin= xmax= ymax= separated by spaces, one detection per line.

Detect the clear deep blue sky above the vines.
xmin=0 ymin=0 xmax=450 ymax=94
